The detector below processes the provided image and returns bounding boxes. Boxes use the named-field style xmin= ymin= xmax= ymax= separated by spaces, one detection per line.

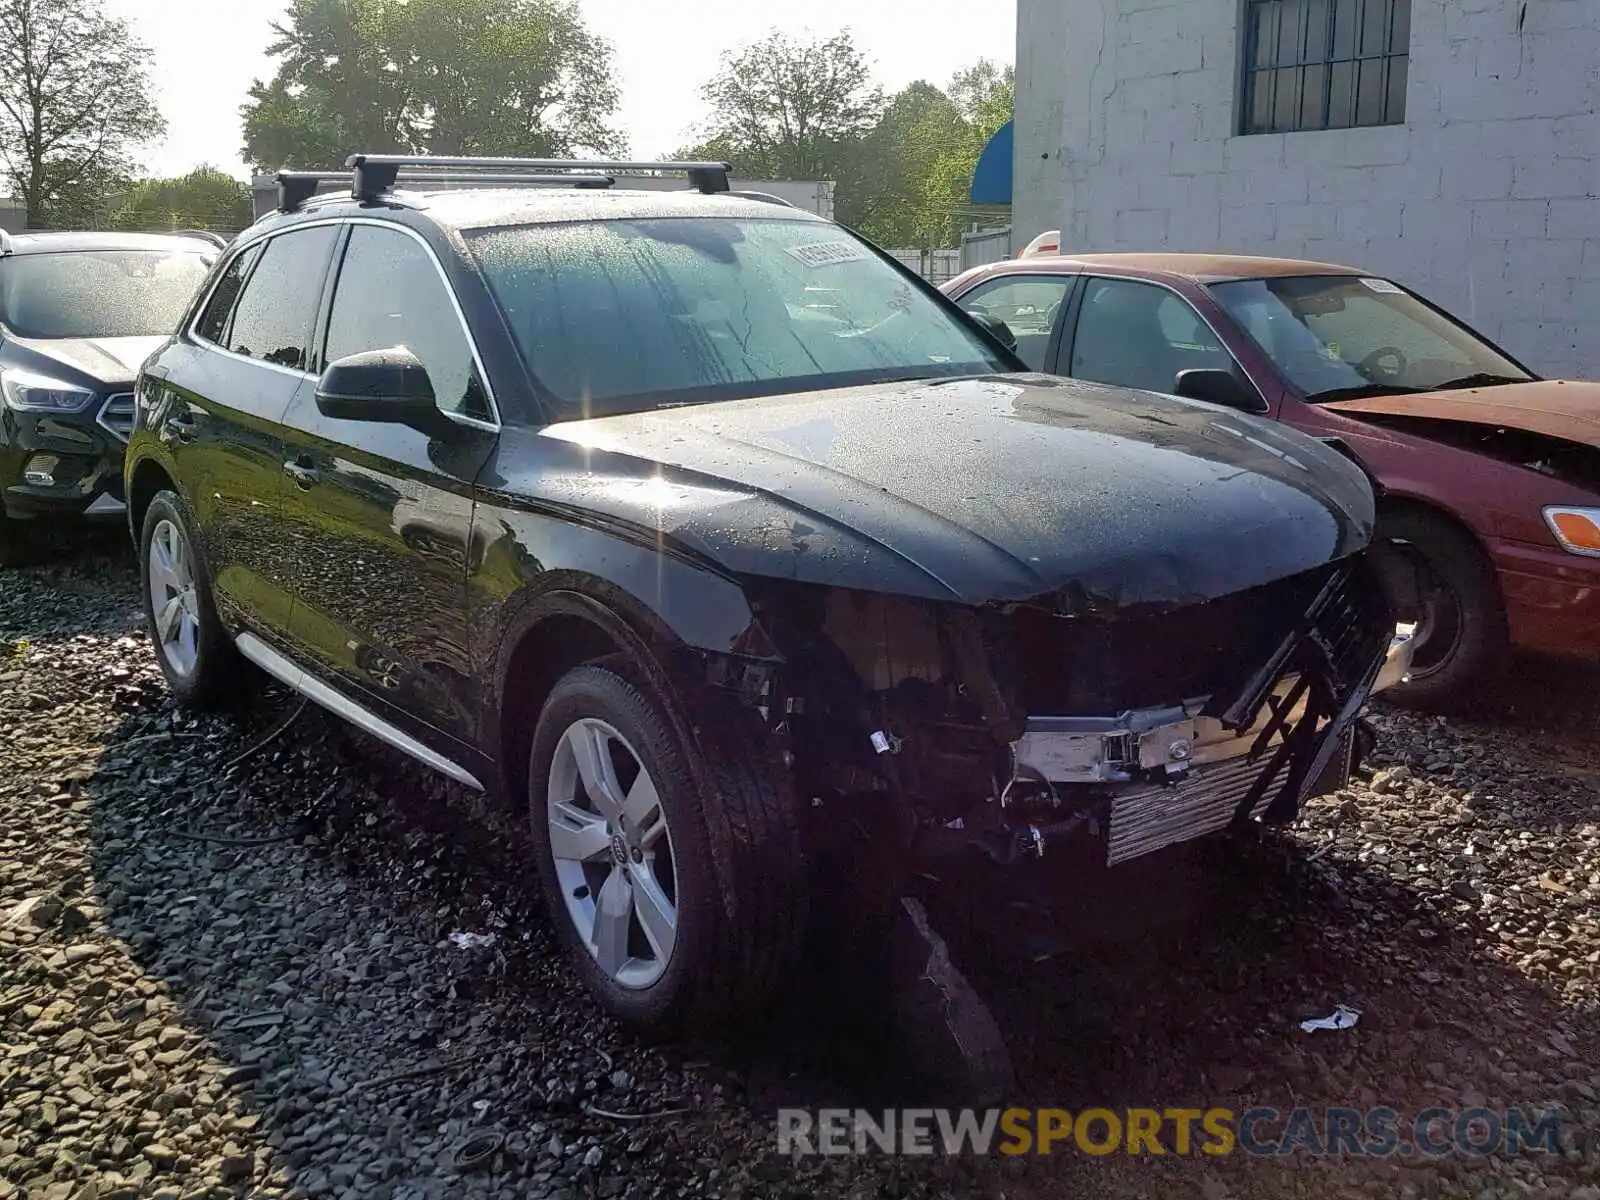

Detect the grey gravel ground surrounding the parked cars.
xmin=0 ymin=546 xmax=1600 ymax=1200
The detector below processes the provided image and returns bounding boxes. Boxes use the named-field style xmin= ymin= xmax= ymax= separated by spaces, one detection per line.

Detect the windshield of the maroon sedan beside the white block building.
xmin=1211 ymin=275 xmax=1530 ymax=402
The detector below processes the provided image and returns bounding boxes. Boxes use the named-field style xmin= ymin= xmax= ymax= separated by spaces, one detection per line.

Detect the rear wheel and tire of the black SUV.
xmin=139 ymin=491 xmax=242 ymax=709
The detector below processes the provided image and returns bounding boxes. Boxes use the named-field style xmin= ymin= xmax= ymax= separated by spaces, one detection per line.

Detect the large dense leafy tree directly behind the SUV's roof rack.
xmin=243 ymin=0 xmax=624 ymax=170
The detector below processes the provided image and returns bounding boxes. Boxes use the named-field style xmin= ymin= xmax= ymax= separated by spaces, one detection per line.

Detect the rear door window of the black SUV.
xmin=227 ymin=226 xmax=338 ymax=371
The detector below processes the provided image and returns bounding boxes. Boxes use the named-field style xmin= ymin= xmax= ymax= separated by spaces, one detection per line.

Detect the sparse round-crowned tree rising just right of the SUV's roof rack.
xmin=693 ymin=30 xmax=885 ymax=179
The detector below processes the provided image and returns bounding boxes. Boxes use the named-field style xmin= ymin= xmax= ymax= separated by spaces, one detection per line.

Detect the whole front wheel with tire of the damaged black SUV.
xmin=528 ymin=659 xmax=805 ymax=1029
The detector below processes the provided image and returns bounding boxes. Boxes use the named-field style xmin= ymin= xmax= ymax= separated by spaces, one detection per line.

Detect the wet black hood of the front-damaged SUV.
xmin=528 ymin=376 xmax=1373 ymax=613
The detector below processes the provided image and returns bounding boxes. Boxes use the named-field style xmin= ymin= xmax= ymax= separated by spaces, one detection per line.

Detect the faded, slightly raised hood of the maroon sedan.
xmin=1323 ymin=379 xmax=1600 ymax=448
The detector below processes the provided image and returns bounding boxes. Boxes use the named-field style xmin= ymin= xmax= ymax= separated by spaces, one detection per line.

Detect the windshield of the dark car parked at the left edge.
xmin=0 ymin=250 xmax=211 ymax=338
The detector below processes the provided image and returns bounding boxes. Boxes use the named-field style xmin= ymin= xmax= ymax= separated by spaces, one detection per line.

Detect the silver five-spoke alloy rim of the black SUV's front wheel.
xmin=546 ymin=717 xmax=678 ymax=989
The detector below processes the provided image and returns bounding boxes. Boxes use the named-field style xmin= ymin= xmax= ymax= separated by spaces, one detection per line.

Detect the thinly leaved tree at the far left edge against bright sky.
xmin=0 ymin=0 xmax=166 ymax=226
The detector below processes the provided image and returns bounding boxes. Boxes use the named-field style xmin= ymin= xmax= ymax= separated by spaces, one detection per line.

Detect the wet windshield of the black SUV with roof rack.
xmin=467 ymin=218 xmax=1014 ymax=416
